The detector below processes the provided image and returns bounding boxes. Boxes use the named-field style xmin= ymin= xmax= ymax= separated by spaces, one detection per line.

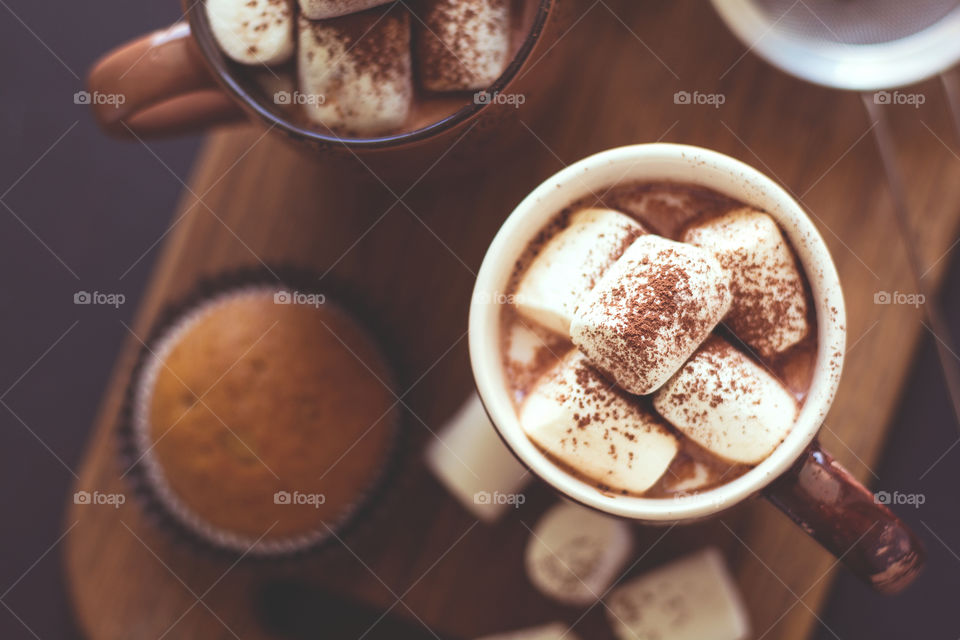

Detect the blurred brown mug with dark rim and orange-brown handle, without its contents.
xmin=88 ymin=0 xmax=571 ymax=160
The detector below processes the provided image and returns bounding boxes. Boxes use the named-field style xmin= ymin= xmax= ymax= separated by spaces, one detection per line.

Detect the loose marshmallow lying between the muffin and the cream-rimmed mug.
xmin=426 ymin=393 xmax=533 ymax=522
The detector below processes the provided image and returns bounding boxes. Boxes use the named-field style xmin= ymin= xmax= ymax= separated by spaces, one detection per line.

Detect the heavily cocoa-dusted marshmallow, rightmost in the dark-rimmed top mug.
xmin=416 ymin=0 xmax=510 ymax=91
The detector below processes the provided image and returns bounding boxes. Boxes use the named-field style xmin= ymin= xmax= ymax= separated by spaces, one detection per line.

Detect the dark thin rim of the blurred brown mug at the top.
xmin=182 ymin=0 xmax=557 ymax=150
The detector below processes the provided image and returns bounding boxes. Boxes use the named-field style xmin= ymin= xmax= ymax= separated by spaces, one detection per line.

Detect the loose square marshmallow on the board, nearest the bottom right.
xmin=607 ymin=548 xmax=750 ymax=640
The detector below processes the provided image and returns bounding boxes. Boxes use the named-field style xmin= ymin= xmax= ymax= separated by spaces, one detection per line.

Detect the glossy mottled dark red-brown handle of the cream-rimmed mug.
xmin=764 ymin=440 xmax=926 ymax=594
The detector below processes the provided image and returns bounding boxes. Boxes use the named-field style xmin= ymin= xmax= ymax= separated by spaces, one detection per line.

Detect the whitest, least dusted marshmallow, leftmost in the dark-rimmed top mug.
xmin=204 ymin=0 xmax=294 ymax=64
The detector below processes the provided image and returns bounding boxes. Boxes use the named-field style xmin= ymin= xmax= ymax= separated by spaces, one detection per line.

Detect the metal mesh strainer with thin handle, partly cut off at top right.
xmin=712 ymin=0 xmax=960 ymax=426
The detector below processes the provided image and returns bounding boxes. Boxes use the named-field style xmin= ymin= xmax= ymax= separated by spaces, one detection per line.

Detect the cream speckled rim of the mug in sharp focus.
xmin=469 ymin=143 xmax=846 ymax=523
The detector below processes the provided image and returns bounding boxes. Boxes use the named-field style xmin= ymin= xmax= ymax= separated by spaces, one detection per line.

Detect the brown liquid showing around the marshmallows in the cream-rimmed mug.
xmin=500 ymin=182 xmax=817 ymax=497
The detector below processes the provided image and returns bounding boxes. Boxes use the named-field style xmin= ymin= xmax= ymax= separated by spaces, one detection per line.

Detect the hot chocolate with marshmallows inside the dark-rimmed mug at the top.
xmin=205 ymin=0 xmax=539 ymax=137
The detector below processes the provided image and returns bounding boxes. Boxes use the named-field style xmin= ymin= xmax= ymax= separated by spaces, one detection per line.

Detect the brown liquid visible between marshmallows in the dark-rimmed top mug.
xmin=229 ymin=0 xmax=540 ymax=137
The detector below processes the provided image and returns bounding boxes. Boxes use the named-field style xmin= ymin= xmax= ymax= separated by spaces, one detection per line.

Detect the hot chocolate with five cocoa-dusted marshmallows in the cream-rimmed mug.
xmin=501 ymin=183 xmax=817 ymax=497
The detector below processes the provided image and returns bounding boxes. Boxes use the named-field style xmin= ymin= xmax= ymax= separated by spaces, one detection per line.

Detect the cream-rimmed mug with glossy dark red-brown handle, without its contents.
xmin=469 ymin=143 xmax=924 ymax=592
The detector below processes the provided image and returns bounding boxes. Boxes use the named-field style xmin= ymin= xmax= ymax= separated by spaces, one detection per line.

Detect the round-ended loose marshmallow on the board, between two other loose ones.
xmin=525 ymin=503 xmax=633 ymax=605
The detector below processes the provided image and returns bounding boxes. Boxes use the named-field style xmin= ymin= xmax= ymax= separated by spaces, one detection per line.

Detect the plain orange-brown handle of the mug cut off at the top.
xmin=87 ymin=22 xmax=244 ymax=139
